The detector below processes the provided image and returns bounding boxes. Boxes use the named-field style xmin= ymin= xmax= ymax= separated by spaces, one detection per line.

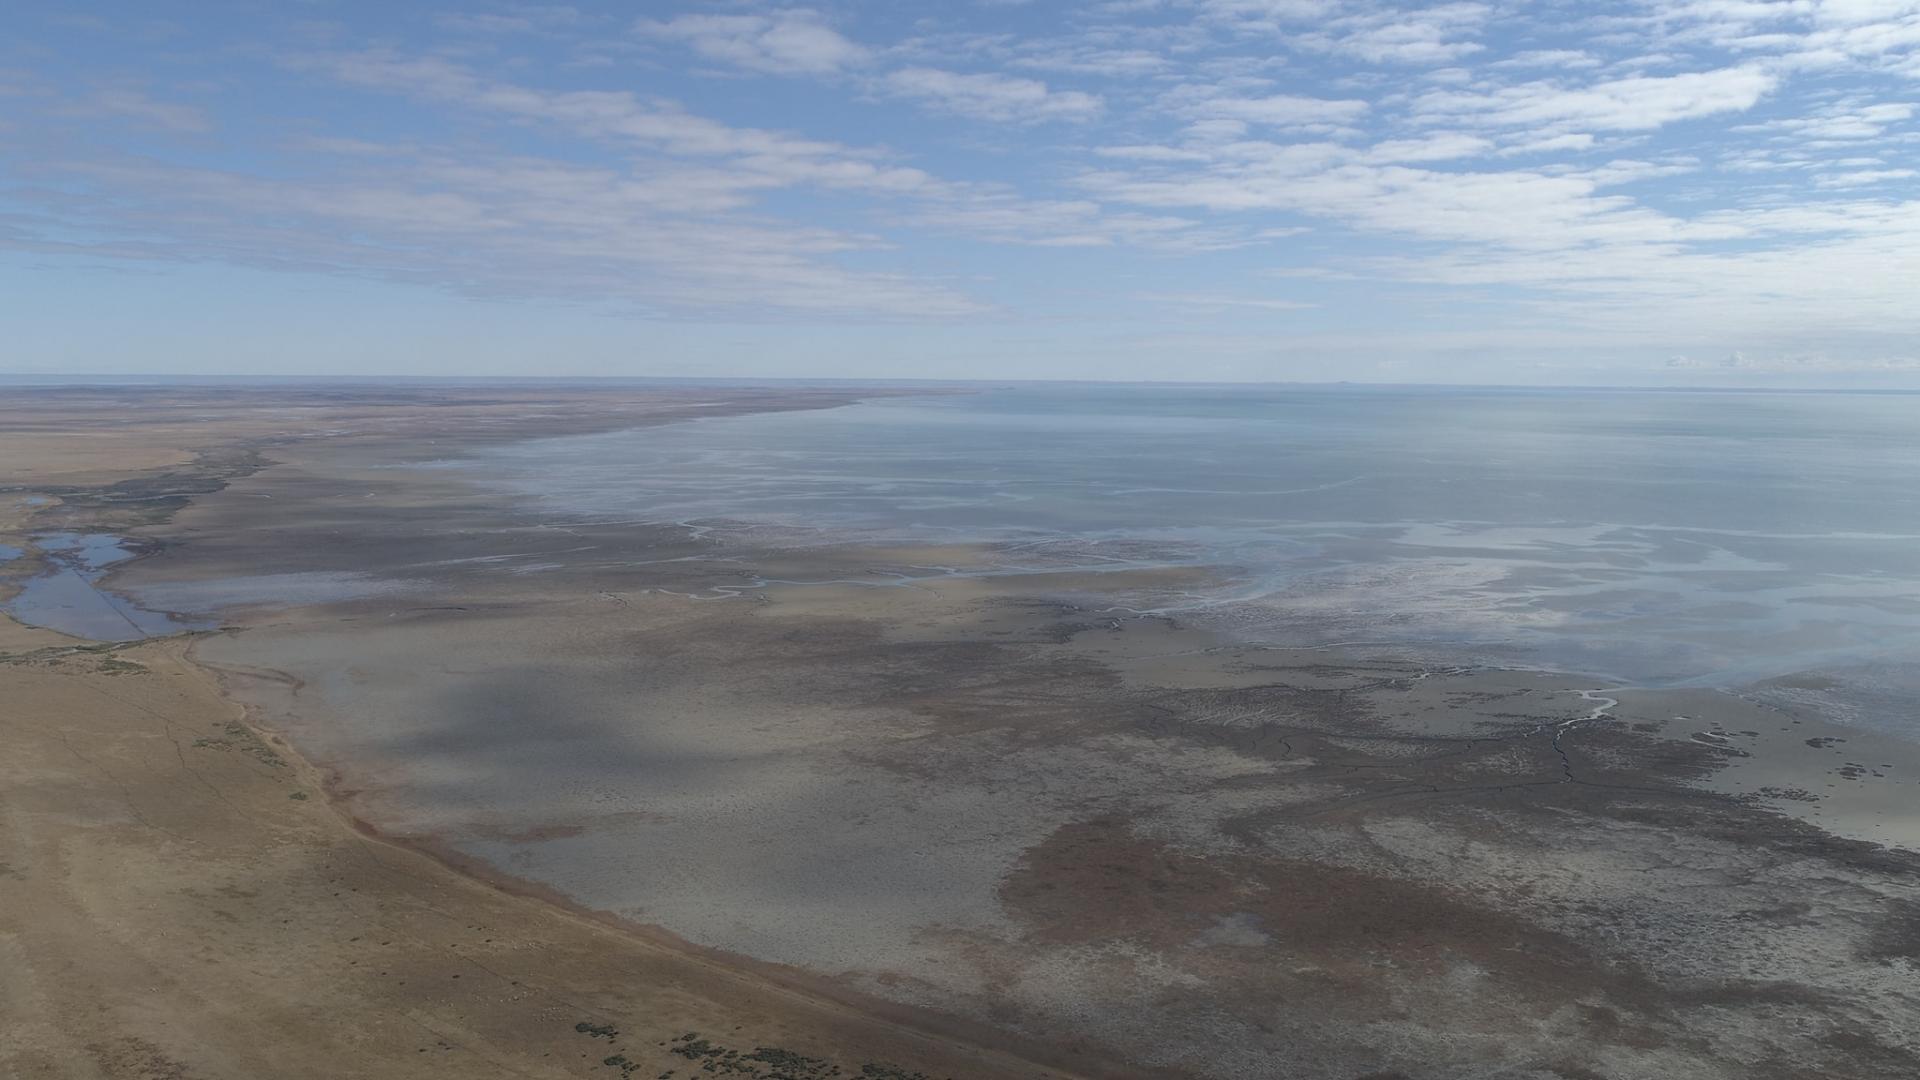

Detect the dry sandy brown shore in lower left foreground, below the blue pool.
xmin=0 ymin=632 xmax=1082 ymax=1080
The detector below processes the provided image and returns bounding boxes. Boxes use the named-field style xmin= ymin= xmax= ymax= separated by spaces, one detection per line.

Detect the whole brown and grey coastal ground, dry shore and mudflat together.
xmin=0 ymin=388 xmax=1920 ymax=1080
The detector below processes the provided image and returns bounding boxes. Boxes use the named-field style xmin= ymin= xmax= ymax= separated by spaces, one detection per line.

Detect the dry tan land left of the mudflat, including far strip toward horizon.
xmin=0 ymin=390 xmax=1062 ymax=1078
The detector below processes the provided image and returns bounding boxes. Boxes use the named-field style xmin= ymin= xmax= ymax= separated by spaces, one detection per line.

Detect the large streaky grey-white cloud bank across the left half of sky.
xmin=0 ymin=52 xmax=1006 ymax=319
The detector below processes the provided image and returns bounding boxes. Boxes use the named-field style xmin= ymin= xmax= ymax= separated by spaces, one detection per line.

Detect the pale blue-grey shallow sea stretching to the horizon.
xmin=480 ymin=386 xmax=1920 ymax=686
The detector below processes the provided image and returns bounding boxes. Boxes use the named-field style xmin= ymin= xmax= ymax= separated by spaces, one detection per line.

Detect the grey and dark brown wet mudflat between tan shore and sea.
xmin=0 ymin=390 xmax=1920 ymax=1078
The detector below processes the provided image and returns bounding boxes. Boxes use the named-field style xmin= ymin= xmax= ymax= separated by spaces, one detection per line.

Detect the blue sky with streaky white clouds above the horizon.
xmin=0 ymin=0 xmax=1920 ymax=388
